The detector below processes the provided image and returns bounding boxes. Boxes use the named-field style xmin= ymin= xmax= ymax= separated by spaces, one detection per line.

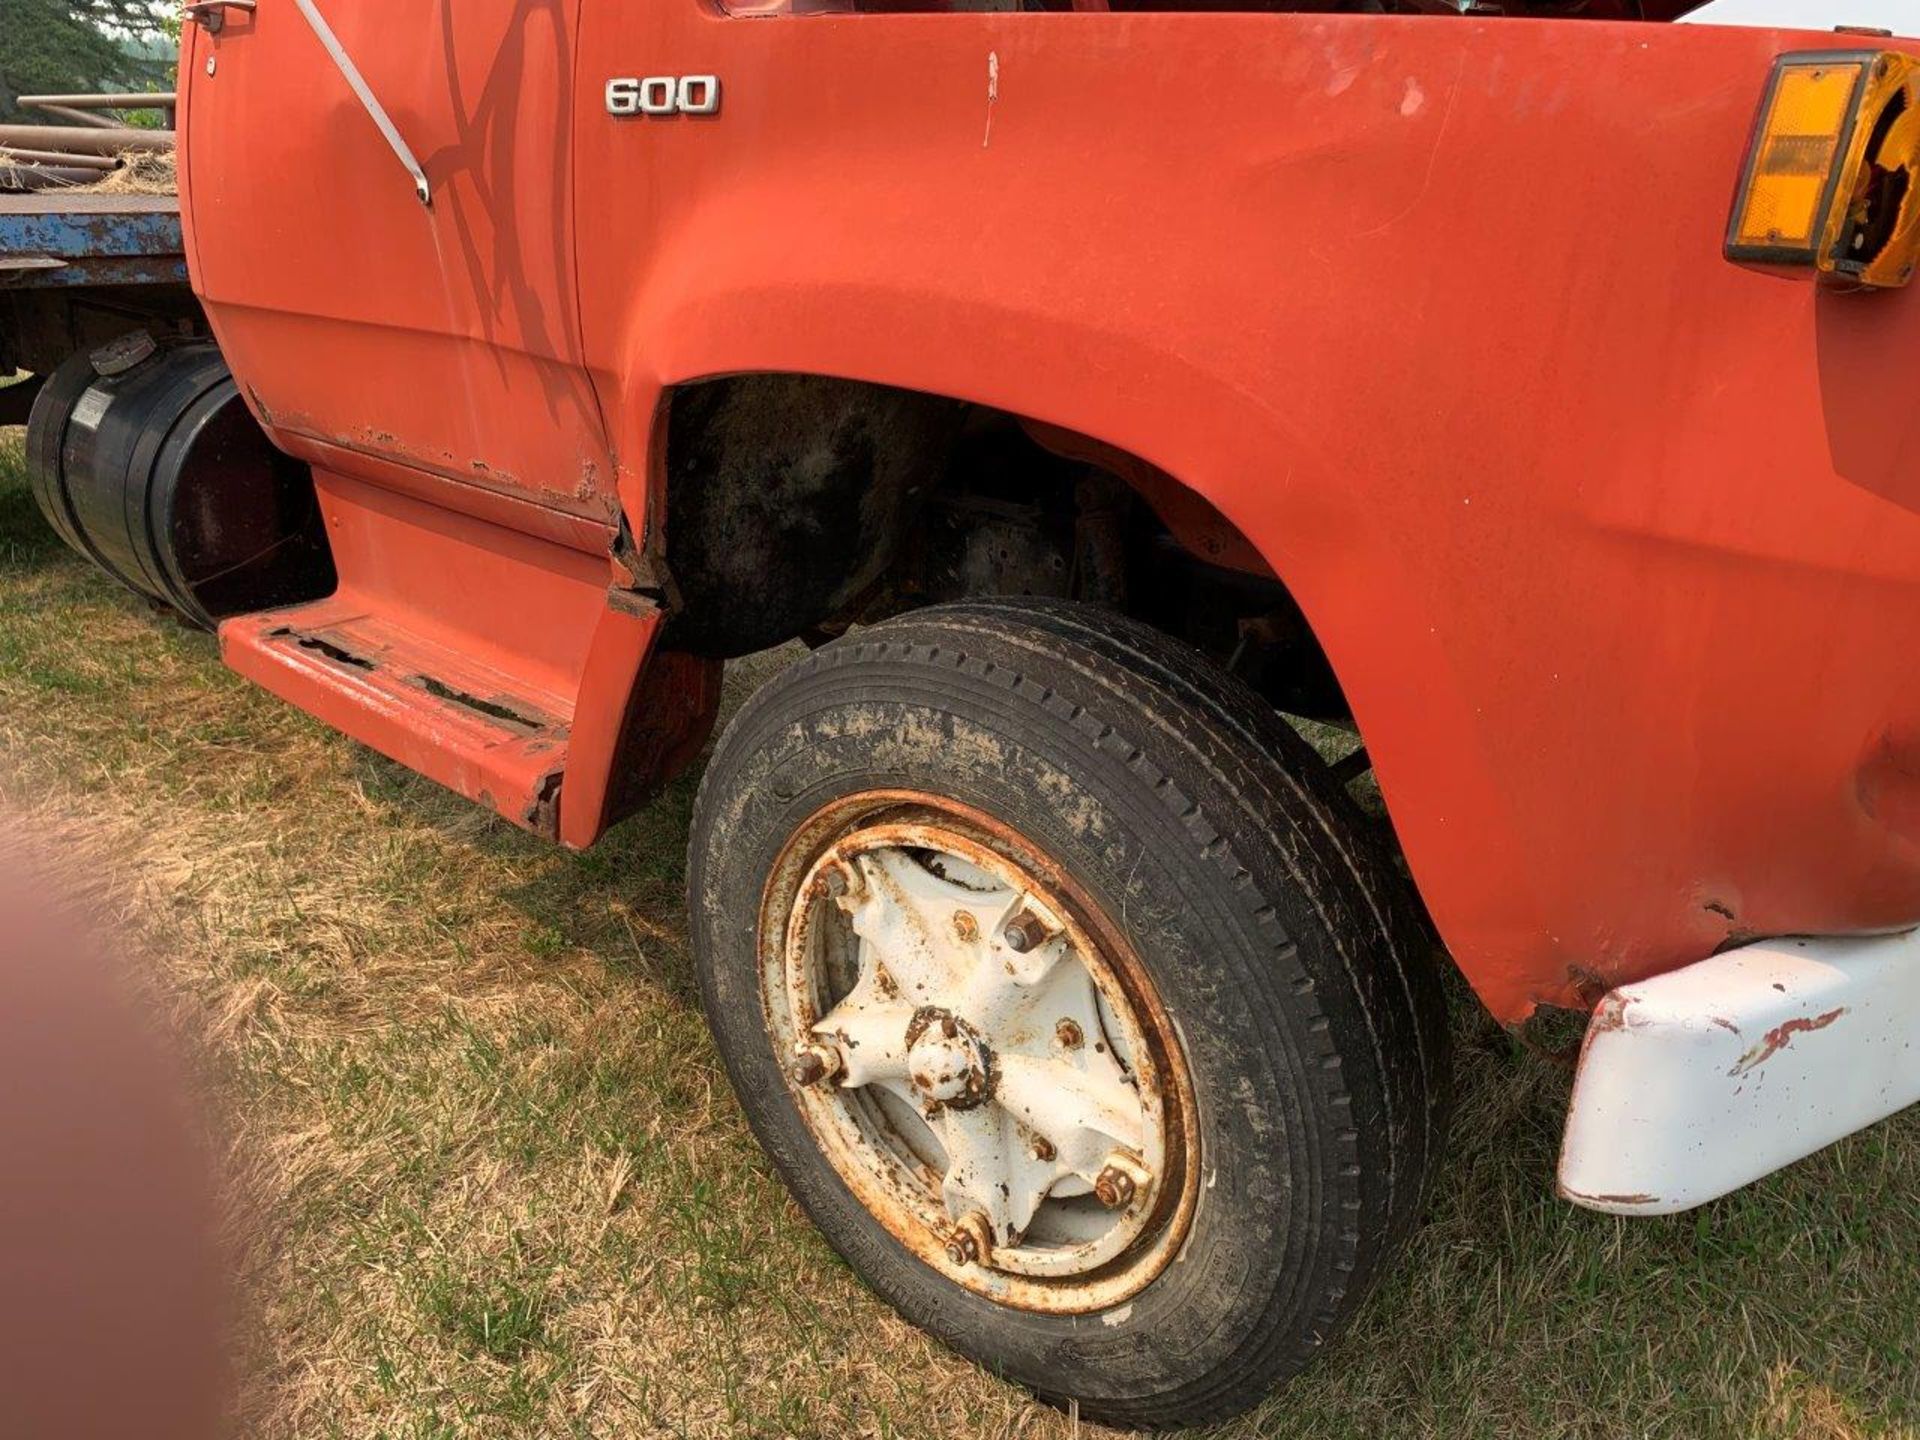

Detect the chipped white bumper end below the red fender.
xmin=1559 ymin=931 xmax=1920 ymax=1215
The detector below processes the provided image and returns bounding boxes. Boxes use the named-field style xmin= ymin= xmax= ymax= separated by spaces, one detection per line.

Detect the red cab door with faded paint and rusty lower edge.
xmin=184 ymin=0 xmax=616 ymax=522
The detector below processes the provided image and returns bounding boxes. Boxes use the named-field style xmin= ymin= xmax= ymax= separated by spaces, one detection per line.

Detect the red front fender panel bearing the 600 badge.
xmin=574 ymin=14 xmax=1920 ymax=1020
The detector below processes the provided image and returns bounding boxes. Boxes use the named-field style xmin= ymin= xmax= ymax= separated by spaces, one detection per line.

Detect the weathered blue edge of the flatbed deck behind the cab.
xmin=0 ymin=190 xmax=186 ymax=290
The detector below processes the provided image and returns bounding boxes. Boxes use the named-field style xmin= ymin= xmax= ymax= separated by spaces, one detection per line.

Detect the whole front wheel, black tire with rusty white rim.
xmin=689 ymin=603 xmax=1446 ymax=1425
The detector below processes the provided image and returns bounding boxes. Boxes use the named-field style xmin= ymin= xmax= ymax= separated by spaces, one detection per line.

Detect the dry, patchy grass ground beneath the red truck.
xmin=0 ymin=440 xmax=1920 ymax=1440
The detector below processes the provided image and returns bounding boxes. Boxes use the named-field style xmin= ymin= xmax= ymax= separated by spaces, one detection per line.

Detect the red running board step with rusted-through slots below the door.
xmin=221 ymin=597 xmax=572 ymax=837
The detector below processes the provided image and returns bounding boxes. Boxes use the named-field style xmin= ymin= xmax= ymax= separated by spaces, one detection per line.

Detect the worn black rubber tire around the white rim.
xmin=689 ymin=601 xmax=1448 ymax=1427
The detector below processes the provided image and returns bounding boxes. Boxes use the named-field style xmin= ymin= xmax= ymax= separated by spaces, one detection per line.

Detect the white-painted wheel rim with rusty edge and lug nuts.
xmin=758 ymin=791 xmax=1196 ymax=1313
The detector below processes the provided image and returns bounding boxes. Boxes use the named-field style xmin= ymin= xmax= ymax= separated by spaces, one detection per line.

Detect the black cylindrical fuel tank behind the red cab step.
xmin=27 ymin=334 xmax=334 ymax=630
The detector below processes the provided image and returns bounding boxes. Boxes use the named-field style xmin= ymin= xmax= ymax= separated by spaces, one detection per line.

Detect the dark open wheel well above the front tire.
xmin=664 ymin=372 xmax=1350 ymax=720
